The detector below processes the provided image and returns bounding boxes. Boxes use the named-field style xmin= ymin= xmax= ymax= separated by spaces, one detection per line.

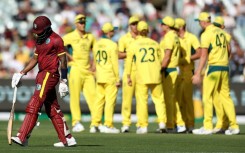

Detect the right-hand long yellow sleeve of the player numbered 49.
xmin=111 ymin=44 xmax=120 ymax=82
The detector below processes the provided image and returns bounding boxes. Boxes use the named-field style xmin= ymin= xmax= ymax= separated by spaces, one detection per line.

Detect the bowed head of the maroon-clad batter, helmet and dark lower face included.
xmin=32 ymin=16 xmax=53 ymax=44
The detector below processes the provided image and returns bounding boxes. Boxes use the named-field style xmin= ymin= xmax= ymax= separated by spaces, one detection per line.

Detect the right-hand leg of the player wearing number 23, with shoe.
xmin=150 ymin=83 xmax=167 ymax=132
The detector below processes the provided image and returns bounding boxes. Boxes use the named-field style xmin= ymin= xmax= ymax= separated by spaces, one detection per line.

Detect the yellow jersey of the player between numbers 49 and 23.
xmin=118 ymin=32 xmax=135 ymax=70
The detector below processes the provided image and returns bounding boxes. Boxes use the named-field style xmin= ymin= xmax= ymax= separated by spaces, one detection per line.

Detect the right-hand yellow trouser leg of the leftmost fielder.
xmin=83 ymin=74 xmax=96 ymax=117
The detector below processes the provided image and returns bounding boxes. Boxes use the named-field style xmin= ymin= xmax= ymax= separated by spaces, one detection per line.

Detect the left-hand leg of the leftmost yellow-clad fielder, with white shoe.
xmin=69 ymin=66 xmax=84 ymax=127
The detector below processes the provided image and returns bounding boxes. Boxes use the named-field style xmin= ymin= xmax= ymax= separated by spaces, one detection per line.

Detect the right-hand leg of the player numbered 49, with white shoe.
xmin=104 ymin=83 xmax=120 ymax=133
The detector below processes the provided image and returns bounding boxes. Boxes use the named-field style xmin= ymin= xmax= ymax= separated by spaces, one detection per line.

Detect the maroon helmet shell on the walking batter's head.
xmin=32 ymin=16 xmax=51 ymax=34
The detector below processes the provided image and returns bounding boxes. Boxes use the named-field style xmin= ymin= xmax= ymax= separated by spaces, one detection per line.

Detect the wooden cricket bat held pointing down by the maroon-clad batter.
xmin=7 ymin=87 xmax=17 ymax=145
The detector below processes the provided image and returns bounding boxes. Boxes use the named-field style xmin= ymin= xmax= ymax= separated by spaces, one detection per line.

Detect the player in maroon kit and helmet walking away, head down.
xmin=11 ymin=16 xmax=76 ymax=147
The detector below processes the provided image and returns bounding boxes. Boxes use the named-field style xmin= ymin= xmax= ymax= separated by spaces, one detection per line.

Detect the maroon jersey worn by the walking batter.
xmin=35 ymin=32 xmax=65 ymax=74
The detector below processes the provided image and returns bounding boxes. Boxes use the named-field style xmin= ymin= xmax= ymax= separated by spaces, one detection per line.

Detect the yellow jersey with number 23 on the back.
xmin=126 ymin=36 xmax=161 ymax=84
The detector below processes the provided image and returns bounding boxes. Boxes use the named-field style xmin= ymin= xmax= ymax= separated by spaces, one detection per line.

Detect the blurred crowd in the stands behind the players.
xmin=0 ymin=0 xmax=245 ymax=82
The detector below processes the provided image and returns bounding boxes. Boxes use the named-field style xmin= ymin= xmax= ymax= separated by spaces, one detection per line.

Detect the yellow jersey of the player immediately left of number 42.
xmin=179 ymin=31 xmax=200 ymax=72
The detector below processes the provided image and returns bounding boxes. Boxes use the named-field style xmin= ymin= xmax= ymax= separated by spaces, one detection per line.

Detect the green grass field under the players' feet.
xmin=0 ymin=121 xmax=245 ymax=153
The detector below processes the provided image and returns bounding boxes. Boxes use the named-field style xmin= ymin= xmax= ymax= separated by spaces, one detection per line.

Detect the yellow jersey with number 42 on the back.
xmin=201 ymin=25 xmax=229 ymax=66
